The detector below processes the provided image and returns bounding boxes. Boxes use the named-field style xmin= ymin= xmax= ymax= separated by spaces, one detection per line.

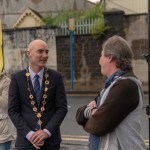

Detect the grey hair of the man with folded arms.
xmin=102 ymin=35 xmax=133 ymax=71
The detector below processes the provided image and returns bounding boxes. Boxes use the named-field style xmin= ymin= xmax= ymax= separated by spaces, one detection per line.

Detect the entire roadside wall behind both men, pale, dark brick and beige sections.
xmin=3 ymin=11 xmax=148 ymax=90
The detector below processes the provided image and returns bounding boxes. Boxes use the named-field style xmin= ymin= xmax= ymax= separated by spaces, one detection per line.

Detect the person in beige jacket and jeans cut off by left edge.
xmin=0 ymin=71 xmax=16 ymax=150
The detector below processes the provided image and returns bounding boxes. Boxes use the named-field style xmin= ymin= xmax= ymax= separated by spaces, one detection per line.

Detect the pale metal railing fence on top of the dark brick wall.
xmin=55 ymin=18 xmax=104 ymax=36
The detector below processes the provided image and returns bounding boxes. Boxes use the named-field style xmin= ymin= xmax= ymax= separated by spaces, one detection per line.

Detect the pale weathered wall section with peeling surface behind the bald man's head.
xmin=3 ymin=28 xmax=57 ymax=74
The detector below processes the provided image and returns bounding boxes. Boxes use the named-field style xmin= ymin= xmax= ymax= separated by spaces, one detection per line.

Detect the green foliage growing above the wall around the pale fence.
xmin=43 ymin=0 xmax=109 ymax=38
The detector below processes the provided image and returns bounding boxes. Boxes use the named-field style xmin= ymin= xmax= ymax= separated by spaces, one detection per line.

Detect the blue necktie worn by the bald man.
xmin=34 ymin=74 xmax=41 ymax=106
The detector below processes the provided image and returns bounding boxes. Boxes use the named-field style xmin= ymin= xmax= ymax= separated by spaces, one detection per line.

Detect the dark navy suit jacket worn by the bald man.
xmin=8 ymin=69 xmax=67 ymax=149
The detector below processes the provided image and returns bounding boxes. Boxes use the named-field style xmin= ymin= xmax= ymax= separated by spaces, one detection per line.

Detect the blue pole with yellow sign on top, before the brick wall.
xmin=69 ymin=18 xmax=75 ymax=90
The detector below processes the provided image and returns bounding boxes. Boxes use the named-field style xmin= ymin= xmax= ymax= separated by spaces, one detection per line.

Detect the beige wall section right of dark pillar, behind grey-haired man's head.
xmin=124 ymin=14 xmax=148 ymax=84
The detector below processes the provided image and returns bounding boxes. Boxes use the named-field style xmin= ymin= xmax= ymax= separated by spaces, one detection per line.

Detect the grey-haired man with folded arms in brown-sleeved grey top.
xmin=76 ymin=35 xmax=146 ymax=150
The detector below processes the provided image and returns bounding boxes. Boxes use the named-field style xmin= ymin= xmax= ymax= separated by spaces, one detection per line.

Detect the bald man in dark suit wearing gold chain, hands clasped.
xmin=8 ymin=39 xmax=67 ymax=150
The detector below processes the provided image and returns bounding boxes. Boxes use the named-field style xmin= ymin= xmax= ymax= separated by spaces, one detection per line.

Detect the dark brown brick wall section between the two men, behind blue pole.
xmin=56 ymin=35 xmax=102 ymax=81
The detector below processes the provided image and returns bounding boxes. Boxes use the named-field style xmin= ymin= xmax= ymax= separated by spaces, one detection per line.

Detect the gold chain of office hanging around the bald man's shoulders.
xmin=26 ymin=68 xmax=49 ymax=129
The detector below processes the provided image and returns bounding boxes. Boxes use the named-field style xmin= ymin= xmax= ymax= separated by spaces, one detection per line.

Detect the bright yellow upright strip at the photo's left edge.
xmin=0 ymin=20 xmax=4 ymax=73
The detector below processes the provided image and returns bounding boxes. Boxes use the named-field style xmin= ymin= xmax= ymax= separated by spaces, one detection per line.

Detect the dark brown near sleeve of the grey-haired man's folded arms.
xmin=84 ymin=79 xmax=139 ymax=136
